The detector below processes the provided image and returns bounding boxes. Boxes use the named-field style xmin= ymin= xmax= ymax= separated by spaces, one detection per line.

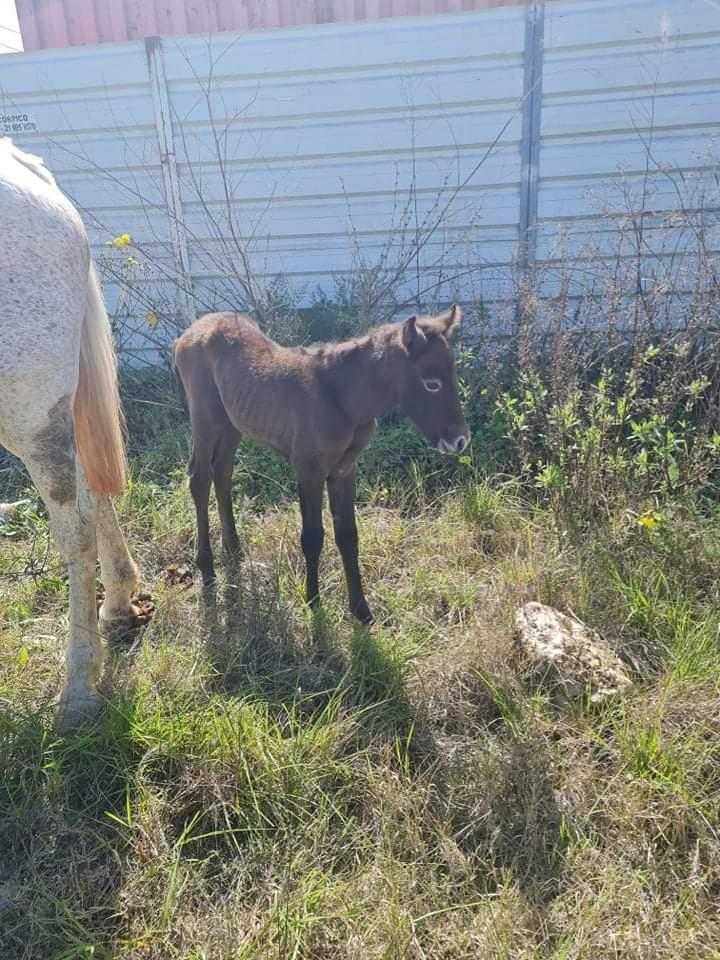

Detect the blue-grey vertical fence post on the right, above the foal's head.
xmin=519 ymin=0 xmax=545 ymax=276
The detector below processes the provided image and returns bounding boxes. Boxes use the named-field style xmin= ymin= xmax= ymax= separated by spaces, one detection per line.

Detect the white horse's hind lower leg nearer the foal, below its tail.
xmin=97 ymin=497 xmax=139 ymax=627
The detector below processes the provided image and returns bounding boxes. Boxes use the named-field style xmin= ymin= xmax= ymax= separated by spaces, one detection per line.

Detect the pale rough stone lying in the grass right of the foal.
xmin=515 ymin=601 xmax=632 ymax=703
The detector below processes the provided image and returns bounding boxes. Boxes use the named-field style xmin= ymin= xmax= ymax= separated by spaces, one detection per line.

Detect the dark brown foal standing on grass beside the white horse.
xmin=175 ymin=306 xmax=469 ymax=623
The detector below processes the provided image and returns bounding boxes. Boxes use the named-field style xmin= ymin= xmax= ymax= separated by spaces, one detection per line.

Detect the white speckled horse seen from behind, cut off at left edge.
xmin=0 ymin=138 xmax=146 ymax=725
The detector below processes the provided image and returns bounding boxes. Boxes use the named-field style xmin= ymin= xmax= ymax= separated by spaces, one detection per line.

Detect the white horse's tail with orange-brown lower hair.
xmin=73 ymin=263 xmax=127 ymax=496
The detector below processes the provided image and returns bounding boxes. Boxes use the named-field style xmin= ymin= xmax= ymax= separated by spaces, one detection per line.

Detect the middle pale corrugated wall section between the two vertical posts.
xmin=165 ymin=8 xmax=523 ymax=316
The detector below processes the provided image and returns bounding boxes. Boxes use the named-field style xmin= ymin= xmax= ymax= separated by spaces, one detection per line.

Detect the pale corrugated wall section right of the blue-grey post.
xmin=537 ymin=0 xmax=720 ymax=293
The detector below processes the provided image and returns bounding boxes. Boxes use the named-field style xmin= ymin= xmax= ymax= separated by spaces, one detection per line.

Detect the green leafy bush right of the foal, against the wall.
xmin=497 ymin=332 xmax=720 ymax=527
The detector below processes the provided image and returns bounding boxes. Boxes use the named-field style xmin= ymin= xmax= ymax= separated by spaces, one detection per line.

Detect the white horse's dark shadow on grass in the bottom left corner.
xmin=0 ymin=702 xmax=138 ymax=960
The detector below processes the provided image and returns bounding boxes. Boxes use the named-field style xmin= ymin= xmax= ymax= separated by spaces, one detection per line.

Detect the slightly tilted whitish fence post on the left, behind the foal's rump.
xmin=145 ymin=37 xmax=195 ymax=324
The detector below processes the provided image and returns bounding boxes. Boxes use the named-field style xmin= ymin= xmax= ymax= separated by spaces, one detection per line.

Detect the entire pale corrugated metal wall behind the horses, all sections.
xmin=0 ymin=0 xmax=720 ymax=356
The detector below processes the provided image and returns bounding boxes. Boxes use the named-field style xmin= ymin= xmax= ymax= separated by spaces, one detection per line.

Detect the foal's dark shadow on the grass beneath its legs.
xmin=195 ymin=561 xmax=432 ymax=762
